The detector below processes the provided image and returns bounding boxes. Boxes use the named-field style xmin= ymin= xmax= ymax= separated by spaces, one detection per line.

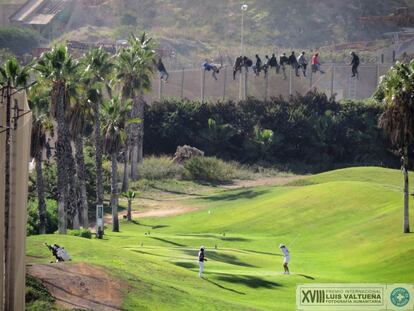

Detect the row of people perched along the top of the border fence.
xmin=157 ymin=51 xmax=360 ymax=81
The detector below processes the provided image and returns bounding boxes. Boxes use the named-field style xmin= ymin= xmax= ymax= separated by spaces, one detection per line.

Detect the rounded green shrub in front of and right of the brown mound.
xmin=184 ymin=157 xmax=240 ymax=183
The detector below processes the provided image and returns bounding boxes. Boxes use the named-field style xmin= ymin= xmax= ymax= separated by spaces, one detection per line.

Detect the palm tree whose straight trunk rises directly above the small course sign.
xmin=82 ymin=48 xmax=114 ymax=222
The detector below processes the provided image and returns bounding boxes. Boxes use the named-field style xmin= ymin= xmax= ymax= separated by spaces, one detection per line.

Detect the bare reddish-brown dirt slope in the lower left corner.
xmin=27 ymin=263 xmax=126 ymax=311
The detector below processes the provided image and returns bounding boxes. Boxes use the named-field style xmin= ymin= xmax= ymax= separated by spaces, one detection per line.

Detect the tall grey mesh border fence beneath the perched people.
xmin=147 ymin=63 xmax=392 ymax=102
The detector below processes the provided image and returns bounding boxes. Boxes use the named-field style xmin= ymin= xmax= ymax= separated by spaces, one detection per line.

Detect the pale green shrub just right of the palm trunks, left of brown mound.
xmin=138 ymin=156 xmax=184 ymax=180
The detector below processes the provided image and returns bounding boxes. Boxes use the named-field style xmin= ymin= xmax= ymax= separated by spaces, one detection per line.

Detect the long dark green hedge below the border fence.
xmin=144 ymin=91 xmax=398 ymax=171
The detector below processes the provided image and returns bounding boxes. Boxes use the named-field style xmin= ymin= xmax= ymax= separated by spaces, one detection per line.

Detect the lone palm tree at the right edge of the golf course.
xmin=377 ymin=60 xmax=414 ymax=233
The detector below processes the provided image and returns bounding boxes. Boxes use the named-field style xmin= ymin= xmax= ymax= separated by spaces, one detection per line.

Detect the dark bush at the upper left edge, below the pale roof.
xmin=0 ymin=27 xmax=39 ymax=54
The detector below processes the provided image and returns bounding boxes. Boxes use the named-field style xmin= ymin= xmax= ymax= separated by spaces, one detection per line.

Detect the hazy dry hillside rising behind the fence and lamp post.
xmin=59 ymin=0 xmax=409 ymax=56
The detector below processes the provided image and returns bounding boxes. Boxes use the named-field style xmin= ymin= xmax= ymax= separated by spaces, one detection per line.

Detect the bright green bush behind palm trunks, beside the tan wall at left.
xmin=26 ymin=199 xmax=58 ymax=235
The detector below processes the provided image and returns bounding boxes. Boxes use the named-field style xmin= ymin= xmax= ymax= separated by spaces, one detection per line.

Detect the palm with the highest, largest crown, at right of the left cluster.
xmin=116 ymin=33 xmax=155 ymax=180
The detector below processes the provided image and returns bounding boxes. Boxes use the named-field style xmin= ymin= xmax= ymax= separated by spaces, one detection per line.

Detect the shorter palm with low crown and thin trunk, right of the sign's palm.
xmin=101 ymin=97 xmax=131 ymax=232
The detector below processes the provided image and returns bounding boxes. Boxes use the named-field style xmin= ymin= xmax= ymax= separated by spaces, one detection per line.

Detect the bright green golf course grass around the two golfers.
xmin=27 ymin=168 xmax=414 ymax=310
